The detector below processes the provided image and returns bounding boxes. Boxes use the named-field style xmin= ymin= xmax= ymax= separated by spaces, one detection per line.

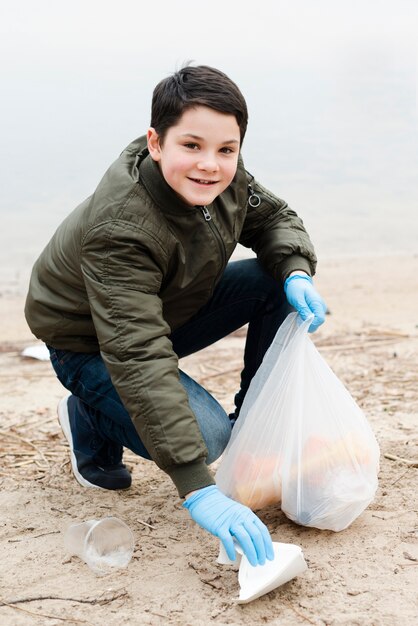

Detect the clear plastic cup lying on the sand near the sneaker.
xmin=64 ymin=517 xmax=135 ymax=576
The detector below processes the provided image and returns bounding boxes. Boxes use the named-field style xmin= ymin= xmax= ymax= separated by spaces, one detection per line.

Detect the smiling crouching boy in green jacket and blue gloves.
xmin=25 ymin=66 xmax=325 ymax=565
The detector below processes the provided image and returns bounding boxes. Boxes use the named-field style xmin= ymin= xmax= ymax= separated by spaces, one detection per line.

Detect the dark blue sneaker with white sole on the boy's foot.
xmin=58 ymin=395 xmax=132 ymax=489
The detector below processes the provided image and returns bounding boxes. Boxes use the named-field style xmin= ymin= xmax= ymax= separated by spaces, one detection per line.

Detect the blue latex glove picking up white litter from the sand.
xmin=183 ymin=485 xmax=274 ymax=565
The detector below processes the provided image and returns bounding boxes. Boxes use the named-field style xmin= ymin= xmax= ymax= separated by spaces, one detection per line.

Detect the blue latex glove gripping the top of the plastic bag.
xmin=284 ymin=274 xmax=327 ymax=333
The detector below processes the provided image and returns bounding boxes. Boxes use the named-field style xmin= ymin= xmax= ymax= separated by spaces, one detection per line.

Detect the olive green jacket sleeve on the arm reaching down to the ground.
xmin=81 ymin=220 xmax=214 ymax=496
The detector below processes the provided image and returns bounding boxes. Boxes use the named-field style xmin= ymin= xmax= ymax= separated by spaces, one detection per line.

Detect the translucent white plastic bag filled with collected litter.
xmin=216 ymin=313 xmax=379 ymax=531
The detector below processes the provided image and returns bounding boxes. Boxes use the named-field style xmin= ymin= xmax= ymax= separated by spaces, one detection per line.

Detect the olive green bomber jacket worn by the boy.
xmin=25 ymin=137 xmax=316 ymax=496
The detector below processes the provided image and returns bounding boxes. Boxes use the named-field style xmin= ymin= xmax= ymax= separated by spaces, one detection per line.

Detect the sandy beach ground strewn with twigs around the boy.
xmin=0 ymin=251 xmax=418 ymax=626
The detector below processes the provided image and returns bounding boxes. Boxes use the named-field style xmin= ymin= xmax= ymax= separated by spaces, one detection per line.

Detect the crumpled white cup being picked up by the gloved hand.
xmin=218 ymin=541 xmax=308 ymax=604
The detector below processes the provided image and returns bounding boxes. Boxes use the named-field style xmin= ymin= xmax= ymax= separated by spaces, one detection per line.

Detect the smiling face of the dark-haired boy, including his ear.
xmin=148 ymin=106 xmax=240 ymax=206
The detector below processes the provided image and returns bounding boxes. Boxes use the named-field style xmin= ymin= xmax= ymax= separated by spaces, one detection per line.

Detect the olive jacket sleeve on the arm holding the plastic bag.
xmin=239 ymin=168 xmax=316 ymax=282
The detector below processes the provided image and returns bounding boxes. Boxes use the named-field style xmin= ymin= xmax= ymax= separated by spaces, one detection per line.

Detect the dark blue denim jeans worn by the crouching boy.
xmin=49 ymin=259 xmax=291 ymax=463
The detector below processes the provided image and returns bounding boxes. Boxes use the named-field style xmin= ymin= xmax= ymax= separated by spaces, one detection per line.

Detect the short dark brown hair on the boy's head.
xmin=151 ymin=65 xmax=248 ymax=144
